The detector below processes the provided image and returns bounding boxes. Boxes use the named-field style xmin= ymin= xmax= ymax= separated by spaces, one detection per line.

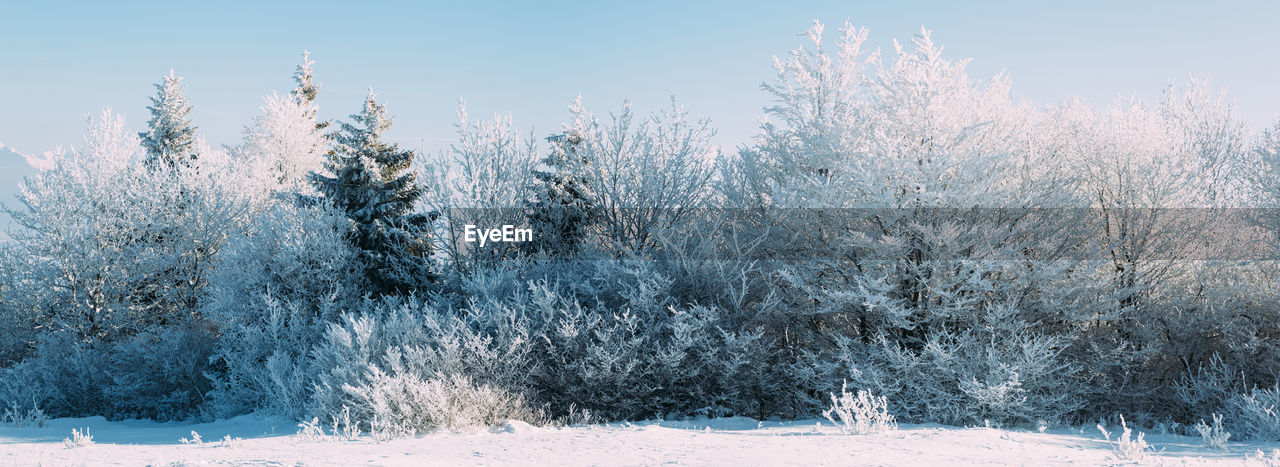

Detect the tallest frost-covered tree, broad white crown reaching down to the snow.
xmin=724 ymin=24 xmax=1078 ymax=422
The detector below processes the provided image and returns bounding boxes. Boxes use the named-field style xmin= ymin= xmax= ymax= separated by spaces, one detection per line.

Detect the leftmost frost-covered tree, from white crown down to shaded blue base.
xmin=4 ymin=113 xmax=242 ymax=418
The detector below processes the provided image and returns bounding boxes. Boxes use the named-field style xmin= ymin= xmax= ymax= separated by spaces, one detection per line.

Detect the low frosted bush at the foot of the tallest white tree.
xmin=794 ymin=300 xmax=1083 ymax=425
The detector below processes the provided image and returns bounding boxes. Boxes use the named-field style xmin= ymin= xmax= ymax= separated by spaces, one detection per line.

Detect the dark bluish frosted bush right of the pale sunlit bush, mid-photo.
xmin=530 ymin=260 xmax=764 ymax=420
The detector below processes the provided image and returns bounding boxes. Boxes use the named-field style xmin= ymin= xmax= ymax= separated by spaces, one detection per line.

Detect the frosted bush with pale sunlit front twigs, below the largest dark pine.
xmin=312 ymin=301 xmax=541 ymax=435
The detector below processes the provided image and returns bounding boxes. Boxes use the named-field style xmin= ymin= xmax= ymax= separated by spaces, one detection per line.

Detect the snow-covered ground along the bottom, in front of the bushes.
xmin=0 ymin=416 xmax=1280 ymax=466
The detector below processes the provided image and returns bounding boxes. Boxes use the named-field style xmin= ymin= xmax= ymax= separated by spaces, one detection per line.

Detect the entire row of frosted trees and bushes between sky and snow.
xmin=0 ymin=23 xmax=1280 ymax=440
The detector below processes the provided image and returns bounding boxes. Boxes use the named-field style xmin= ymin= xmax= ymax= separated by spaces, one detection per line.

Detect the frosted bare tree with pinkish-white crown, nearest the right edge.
xmin=1055 ymin=78 xmax=1272 ymax=421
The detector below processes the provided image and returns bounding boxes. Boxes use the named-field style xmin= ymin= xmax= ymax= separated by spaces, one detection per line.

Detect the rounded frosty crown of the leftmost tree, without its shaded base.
xmin=13 ymin=114 xmax=239 ymax=339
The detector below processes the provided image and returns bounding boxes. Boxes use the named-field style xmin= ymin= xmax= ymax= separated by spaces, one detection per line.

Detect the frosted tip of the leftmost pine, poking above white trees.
xmin=138 ymin=70 xmax=196 ymax=168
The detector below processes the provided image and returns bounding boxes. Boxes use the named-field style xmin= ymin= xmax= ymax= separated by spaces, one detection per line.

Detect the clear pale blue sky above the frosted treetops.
xmin=0 ymin=1 xmax=1280 ymax=157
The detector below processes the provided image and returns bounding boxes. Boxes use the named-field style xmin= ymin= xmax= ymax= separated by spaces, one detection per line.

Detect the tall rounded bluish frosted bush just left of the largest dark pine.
xmin=201 ymin=200 xmax=364 ymax=417
